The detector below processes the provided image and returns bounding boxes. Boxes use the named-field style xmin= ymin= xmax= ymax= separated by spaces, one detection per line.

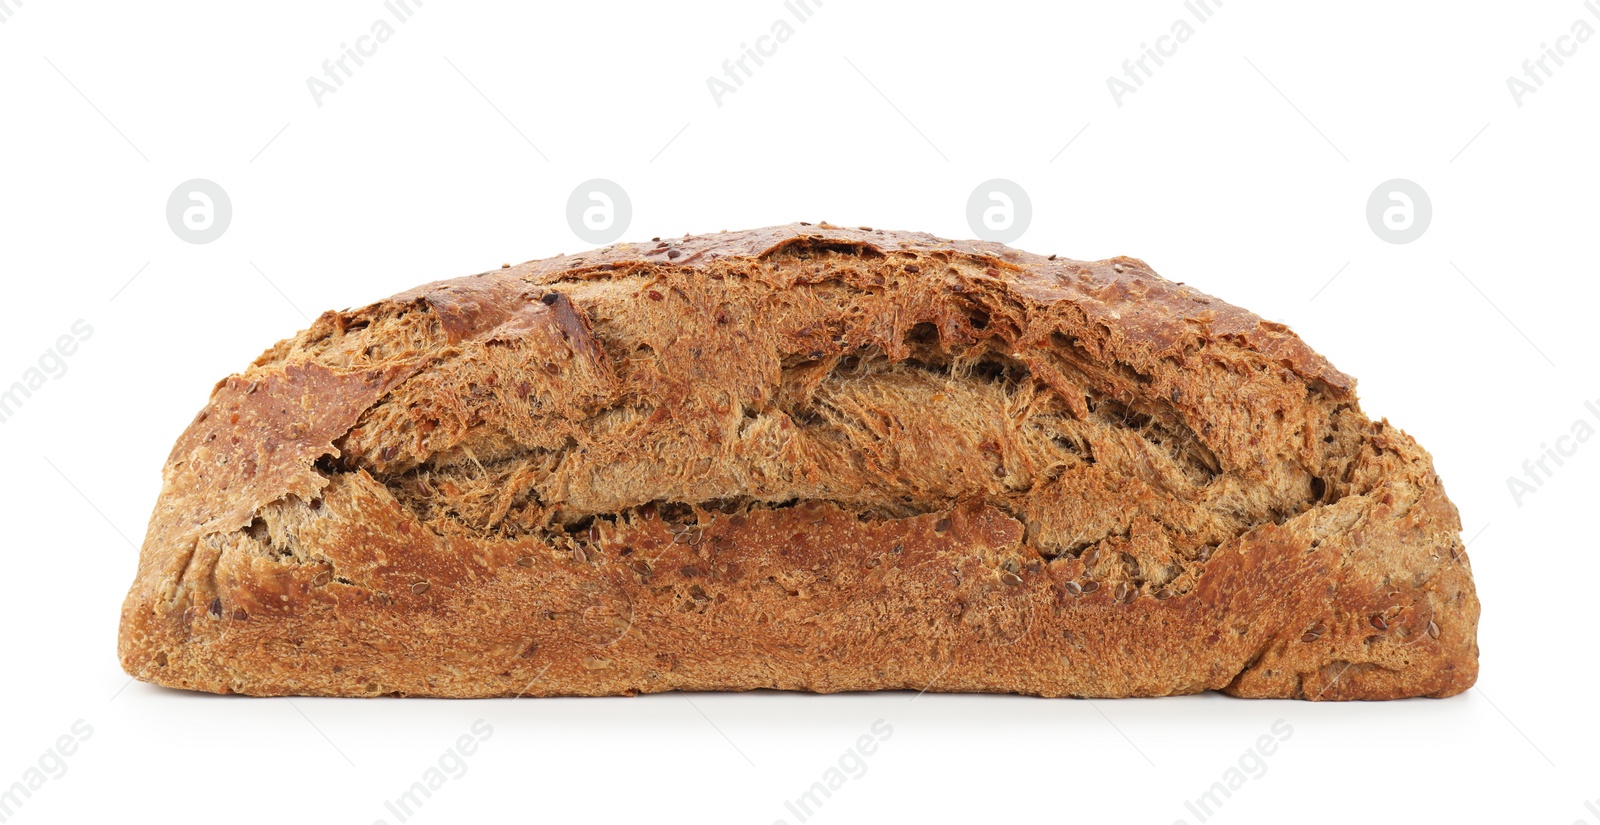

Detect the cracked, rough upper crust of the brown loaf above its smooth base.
xmin=141 ymin=222 xmax=1388 ymax=607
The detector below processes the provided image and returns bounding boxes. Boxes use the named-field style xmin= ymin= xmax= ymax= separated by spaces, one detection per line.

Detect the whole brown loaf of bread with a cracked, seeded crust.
xmin=118 ymin=224 xmax=1478 ymax=700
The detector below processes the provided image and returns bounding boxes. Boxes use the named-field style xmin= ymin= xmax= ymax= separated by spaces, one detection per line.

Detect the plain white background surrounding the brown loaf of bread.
xmin=0 ymin=0 xmax=1600 ymax=825
